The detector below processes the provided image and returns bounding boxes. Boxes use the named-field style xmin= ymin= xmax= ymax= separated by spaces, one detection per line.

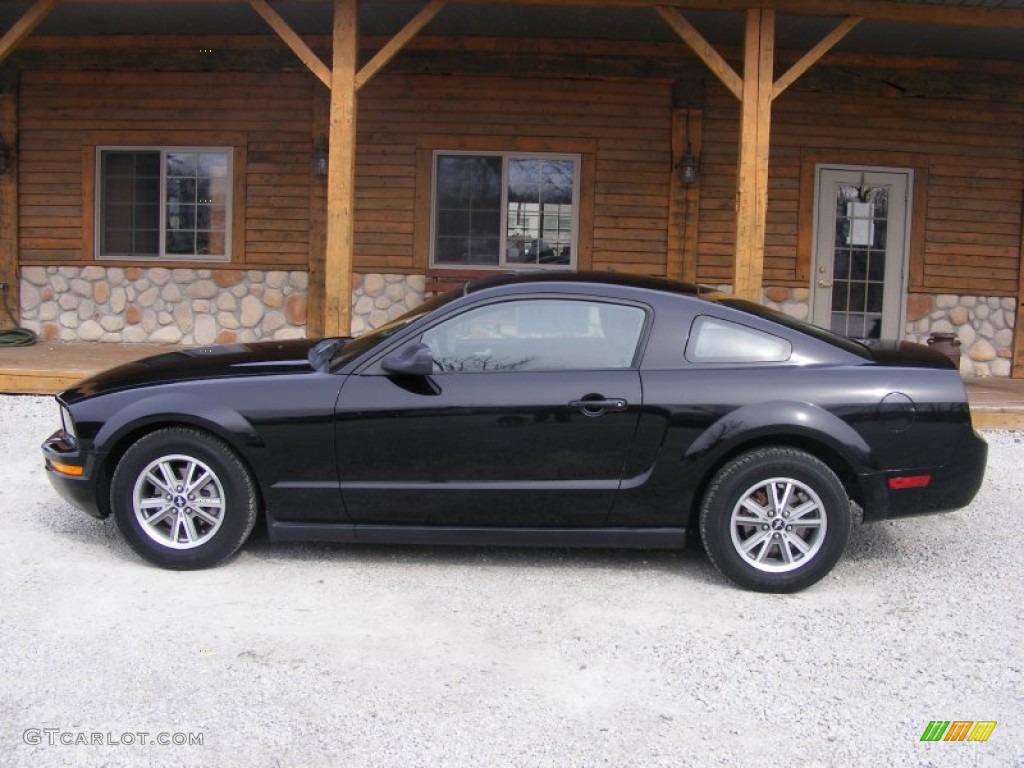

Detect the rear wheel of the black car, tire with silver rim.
xmin=700 ymin=446 xmax=852 ymax=592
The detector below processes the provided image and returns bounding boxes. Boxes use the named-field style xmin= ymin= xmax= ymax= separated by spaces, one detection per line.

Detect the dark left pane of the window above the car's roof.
xmin=434 ymin=155 xmax=502 ymax=265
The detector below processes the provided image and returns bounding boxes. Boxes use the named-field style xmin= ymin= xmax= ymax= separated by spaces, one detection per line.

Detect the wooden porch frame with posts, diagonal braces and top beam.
xmin=0 ymin=0 xmax=1024 ymax=336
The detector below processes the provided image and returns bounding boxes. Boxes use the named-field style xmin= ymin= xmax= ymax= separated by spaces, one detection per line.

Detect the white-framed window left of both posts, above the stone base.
xmin=95 ymin=146 xmax=232 ymax=261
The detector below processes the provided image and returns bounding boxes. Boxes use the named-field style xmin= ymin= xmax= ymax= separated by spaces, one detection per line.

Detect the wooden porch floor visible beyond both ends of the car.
xmin=0 ymin=342 xmax=1024 ymax=429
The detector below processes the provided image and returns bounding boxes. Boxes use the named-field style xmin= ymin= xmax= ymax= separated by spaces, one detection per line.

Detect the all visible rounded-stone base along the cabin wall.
xmin=14 ymin=265 xmax=1017 ymax=377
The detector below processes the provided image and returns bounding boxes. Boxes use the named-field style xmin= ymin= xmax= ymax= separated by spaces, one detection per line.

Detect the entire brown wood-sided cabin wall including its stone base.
xmin=9 ymin=41 xmax=1024 ymax=375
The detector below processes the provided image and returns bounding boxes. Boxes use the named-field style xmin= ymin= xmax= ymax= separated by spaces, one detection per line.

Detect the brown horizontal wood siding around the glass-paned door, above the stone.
xmin=698 ymin=81 xmax=1024 ymax=296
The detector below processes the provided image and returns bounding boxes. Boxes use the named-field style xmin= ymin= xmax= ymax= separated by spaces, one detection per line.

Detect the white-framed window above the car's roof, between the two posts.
xmin=430 ymin=151 xmax=580 ymax=269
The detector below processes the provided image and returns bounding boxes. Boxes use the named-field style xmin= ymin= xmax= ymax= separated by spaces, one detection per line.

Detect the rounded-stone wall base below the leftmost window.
xmin=20 ymin=265 xmax=309 ymax=345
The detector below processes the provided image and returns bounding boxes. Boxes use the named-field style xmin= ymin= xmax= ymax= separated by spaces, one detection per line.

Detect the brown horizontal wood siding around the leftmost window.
xmin=18 ymin=72 xmax=313 ymax=268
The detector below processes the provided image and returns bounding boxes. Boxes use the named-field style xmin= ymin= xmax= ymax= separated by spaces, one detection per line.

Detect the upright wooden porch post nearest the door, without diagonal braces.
xmin=732 ymin=9 xmax=775 ymax=303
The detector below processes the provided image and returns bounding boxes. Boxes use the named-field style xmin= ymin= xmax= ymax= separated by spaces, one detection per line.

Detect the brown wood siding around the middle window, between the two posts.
xmin=355 ymin=74 xmax=672 ymax=274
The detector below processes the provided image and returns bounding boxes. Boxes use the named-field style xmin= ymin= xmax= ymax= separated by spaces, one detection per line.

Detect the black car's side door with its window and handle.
xmin=336 ymin=298 xmax=647 ymax=527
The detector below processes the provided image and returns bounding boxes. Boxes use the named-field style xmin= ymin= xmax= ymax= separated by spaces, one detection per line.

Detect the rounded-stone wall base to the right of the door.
xmin=906 ymin=294 xmax=1017 ymax=377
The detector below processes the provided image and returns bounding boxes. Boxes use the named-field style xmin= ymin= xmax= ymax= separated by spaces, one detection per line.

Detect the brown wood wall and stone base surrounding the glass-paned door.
xmin=696 ymin=75 xmax=1024 ymax=376
